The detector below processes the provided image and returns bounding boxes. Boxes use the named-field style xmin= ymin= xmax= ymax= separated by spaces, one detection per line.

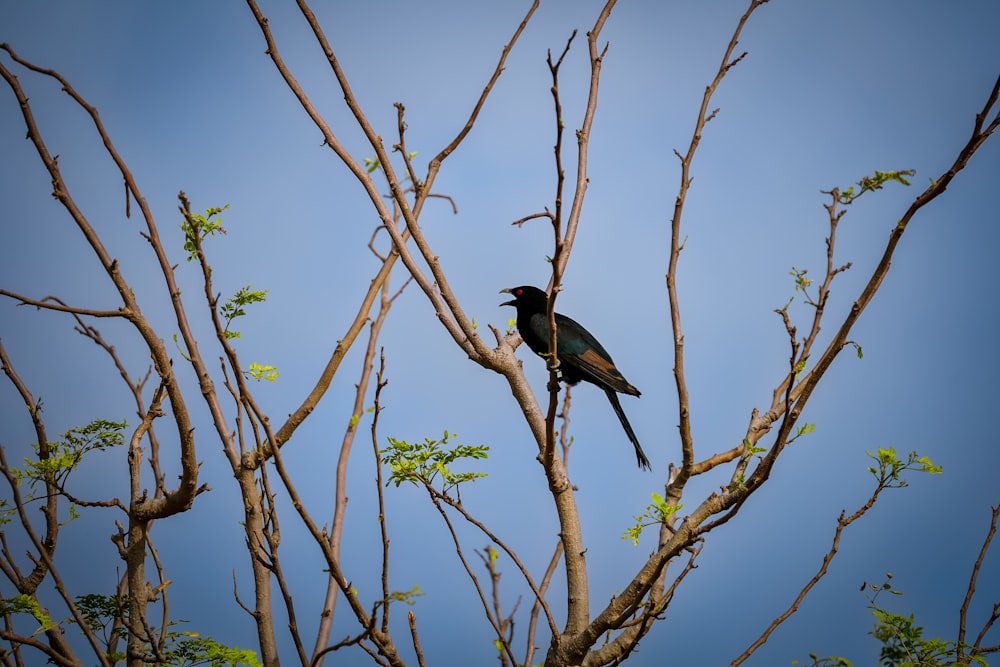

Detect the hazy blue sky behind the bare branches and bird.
xmin=0 ymin=0 xmax=1000 ymax=665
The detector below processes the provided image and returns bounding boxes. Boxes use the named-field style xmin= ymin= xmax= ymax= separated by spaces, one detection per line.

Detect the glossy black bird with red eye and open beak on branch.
xmin=500 ymin=285 xmax=650 ymax=470
